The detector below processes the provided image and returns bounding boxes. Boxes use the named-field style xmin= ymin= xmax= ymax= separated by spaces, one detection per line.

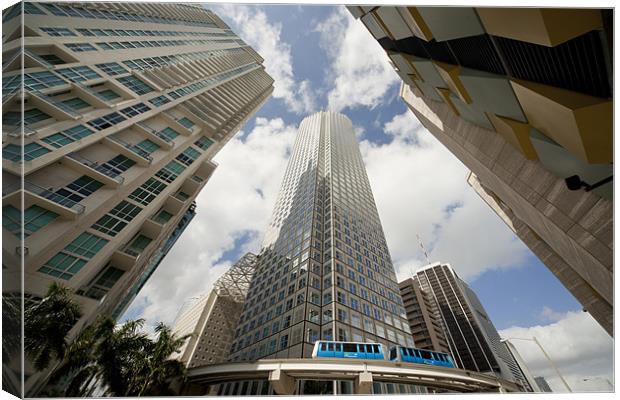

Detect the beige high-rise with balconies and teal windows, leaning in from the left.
xmin=2 ymin=2 xmax=273 ymax=396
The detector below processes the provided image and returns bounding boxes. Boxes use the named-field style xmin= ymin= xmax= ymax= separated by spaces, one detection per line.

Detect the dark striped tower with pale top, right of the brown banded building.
xmin=415 ymin=263 xmax=531 ymax=391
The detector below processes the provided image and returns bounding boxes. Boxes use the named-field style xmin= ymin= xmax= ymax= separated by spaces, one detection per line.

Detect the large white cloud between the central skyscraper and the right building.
xmin=360 ymin=111 xmax=528 ymax=280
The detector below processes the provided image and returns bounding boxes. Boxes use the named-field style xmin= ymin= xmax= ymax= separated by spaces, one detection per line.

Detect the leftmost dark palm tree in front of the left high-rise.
xmin=24 ymin=282 xmax=82 ymax=371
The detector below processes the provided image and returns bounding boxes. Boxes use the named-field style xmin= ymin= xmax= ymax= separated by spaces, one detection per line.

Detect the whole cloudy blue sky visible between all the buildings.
xmin=125 ymin=4 xmax=612 ymax=390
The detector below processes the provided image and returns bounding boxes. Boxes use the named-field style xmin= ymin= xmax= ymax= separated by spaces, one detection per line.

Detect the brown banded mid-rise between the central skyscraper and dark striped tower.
xmin=398 ymin=277 xmax=450 ymax=353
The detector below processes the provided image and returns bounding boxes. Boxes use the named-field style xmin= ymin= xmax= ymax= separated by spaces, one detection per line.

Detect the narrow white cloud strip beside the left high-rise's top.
xmin=211 ymin=4 xmax=316 ymax=114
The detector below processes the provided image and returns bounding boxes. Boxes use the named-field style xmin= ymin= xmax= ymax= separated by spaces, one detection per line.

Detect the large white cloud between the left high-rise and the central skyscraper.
xmin=127 ymin=118 xmax=296 ymax=326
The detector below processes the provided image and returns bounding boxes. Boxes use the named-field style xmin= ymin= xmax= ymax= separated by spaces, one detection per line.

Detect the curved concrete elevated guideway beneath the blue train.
xmin=187 ymin=358 xmax=523 ymax=395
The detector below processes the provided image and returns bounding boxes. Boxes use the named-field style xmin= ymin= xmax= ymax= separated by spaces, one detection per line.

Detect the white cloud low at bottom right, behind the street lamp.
xmin=500 ymin=307 xmax=614 ymax=392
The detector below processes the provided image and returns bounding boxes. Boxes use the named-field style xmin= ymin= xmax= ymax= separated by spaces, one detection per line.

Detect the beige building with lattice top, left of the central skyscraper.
xmin=173 ymin=253 xmax=257 ymax=368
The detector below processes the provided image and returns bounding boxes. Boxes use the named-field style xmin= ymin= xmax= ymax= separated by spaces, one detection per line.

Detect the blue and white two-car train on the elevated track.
xmin=312 ymin=341 xmax=455 ymax=368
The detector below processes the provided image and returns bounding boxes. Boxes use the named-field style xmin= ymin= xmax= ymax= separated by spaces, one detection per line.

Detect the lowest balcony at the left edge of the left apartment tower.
xmin=2 ymin=181 xmax=86 ymax=219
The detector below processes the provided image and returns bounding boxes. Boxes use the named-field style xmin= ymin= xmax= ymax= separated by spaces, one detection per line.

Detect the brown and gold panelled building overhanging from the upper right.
xmin=349 ymin=6 xmax=613 ymax=335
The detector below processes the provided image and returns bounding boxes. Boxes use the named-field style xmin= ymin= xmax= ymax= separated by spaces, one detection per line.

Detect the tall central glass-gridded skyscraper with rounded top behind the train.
xmin=230 ymin=111 xmax=413 ymax=361
